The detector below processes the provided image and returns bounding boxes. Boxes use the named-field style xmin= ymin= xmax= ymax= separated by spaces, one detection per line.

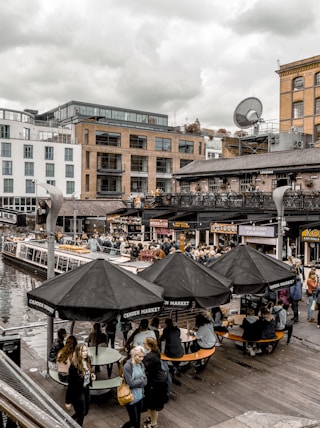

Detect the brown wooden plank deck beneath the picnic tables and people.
xmin=22 ymin=332 xmax=320 ymax=428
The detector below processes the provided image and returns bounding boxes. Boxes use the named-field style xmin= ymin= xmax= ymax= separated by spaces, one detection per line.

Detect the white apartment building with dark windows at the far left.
xmin=0 ymin=108 xmax=81 ymax=213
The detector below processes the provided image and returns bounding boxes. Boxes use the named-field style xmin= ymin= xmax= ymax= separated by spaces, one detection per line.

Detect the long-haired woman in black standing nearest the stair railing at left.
xmin=66 ymin=343 xmax=96 ymax=426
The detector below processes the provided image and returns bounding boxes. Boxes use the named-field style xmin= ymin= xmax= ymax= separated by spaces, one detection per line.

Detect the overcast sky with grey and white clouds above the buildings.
xmin=0 ymin=0 xmax=320 ymax=131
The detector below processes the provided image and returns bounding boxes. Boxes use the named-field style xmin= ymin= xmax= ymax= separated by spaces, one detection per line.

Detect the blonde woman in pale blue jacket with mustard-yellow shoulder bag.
xmin=122 ymin=346 xmax=147 ymax=428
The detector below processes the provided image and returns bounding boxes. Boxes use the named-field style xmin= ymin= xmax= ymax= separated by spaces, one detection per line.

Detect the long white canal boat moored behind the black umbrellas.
xmin=1 ymin=239 xmax=150 ymax=278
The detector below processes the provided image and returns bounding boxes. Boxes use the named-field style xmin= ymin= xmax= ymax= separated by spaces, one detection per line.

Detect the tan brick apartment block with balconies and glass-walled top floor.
xmin=38 ymin=101 xmax=205 ymax=199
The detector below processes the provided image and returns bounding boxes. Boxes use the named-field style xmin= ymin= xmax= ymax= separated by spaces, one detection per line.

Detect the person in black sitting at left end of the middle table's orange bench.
xmin=160 ymin=318 xmax=184 ymax=385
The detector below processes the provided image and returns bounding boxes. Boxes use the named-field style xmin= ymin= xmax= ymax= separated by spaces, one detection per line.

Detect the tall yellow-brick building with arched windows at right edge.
xmin=276 ymin=55 xmax=320 ymax=145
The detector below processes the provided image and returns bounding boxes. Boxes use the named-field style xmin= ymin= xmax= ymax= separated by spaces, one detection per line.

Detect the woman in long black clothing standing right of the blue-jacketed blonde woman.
xmin=143 ymin=337 xmax=168 ymax=428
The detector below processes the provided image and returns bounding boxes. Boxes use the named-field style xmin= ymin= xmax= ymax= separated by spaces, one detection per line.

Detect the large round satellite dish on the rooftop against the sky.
xmin=233 ymin=97 xmax=263 ymax=128
